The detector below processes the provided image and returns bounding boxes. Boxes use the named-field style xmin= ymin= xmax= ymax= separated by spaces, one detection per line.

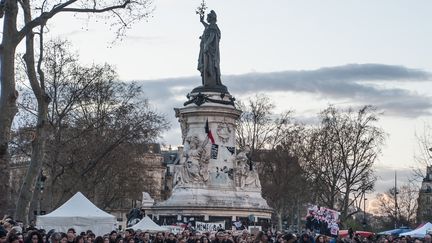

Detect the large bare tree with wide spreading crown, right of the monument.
xmin=302 ymin=106 xmax=385 ymax=223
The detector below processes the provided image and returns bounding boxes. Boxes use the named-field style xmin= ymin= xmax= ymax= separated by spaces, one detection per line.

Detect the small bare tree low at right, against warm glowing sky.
xmin=375 ymin=183 xmax=419 ymax=227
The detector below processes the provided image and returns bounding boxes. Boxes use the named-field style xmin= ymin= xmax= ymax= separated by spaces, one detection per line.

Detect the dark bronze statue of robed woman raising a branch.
xmin=198 ymin=10 xmax=222 ymax=87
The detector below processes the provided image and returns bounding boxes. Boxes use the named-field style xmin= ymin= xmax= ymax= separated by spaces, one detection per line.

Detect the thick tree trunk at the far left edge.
xmin=0 ymin=0 xmax=18 ymax=215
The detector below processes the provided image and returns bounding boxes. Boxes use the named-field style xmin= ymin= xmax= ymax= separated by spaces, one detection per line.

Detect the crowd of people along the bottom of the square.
xmin=0 ymin=217 xmax=432 ymax=243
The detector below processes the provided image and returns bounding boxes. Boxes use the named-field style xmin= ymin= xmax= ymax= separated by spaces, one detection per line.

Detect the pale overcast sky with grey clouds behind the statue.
xmin=34 ymin=0 xmax=432 ymax=197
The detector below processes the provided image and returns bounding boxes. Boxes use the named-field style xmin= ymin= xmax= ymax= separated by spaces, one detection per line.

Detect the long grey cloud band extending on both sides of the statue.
xmin=135 ymin=64 xmax=432 ymax=117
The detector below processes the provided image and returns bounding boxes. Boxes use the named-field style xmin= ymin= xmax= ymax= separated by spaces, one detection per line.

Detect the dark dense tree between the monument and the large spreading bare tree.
xmin=257 ymin=123 xmax=311 ymax=230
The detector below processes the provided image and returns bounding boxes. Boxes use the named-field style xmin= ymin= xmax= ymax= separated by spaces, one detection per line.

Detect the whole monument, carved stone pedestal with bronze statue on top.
xmin=147 ymin=8 xmax=272 ymax=227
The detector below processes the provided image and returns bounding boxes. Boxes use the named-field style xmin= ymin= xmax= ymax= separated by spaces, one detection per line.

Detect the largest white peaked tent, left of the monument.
xmin=36 ymin=192 xmax=117 ymax=235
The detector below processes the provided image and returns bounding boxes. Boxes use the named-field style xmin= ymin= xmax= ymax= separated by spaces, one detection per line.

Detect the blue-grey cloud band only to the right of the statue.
xmin=229 ymin=64 xmax=432 ymax=117
